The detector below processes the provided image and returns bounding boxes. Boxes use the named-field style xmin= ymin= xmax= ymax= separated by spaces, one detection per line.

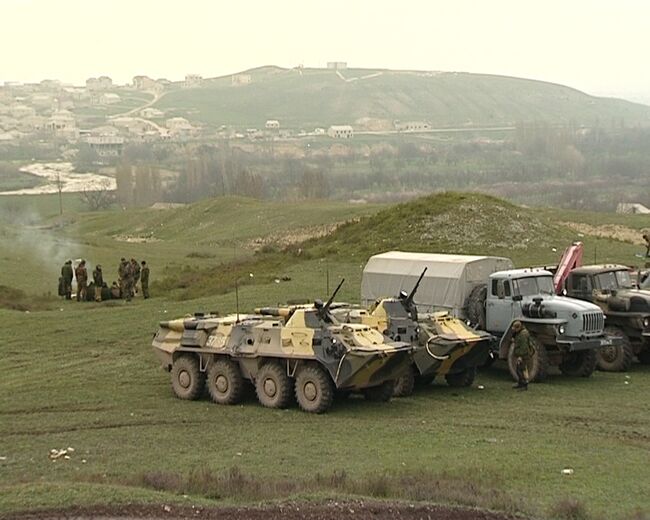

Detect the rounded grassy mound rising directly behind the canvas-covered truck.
xmin=305 ymin=193 xmax=570 ymax=257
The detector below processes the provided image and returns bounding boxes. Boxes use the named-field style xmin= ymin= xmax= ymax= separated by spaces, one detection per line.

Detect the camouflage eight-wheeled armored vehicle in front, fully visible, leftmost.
xmin=153 ymin=282 xmax=411 ymax=413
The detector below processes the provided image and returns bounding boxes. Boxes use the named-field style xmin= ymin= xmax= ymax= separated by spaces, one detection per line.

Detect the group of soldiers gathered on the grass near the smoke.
xmin=59 ymin=257 xmax=149 ymax=302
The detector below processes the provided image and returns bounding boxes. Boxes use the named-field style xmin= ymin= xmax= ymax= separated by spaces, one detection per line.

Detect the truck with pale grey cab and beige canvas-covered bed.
xmin=362 ymin=251 xmax=619 ymax=381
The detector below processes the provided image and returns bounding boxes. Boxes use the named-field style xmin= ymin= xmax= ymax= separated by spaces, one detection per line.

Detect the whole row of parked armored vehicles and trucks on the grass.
xmin=152 ymin=251 xmax=650 ymax=413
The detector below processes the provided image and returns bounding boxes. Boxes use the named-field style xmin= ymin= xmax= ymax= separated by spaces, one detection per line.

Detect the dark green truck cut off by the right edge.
xmin=560 ymin=265 xmax=650 ymax=372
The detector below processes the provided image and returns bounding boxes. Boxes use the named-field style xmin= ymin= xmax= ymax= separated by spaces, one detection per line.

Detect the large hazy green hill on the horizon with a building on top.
xmin=156 ymin=67 xmax=650 ymax=130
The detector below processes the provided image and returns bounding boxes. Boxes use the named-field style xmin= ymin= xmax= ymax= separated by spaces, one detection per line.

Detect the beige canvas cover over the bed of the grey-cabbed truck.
xmin=361 ymin=251 xmax=513 ymax=317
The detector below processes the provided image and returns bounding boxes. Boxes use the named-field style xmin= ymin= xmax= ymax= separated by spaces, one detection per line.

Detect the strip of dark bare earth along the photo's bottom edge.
xmin=5 ymin=501 xmax=522 ymax=520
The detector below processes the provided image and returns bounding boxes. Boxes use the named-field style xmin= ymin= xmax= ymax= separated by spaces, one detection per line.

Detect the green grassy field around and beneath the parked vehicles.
xmin=0 ymin=194 xmax=650 ymax=520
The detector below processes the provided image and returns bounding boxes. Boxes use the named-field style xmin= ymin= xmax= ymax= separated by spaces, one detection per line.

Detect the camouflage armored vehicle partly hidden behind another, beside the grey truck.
xmin=333 ymin=268 xmax=488 ymax=397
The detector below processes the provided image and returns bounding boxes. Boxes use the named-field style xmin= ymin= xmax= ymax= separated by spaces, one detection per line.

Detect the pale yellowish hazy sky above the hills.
xmin=0 ymin=0 xmax=650 ymax=97
